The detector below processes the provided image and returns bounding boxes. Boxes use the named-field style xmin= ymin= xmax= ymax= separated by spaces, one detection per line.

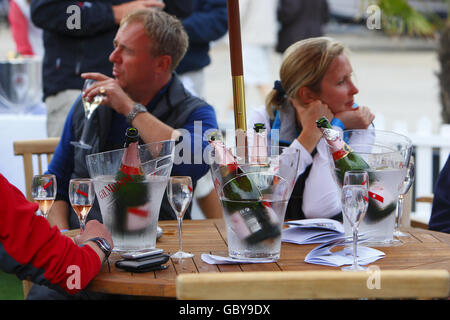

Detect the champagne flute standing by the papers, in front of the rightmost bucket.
xmin=341 ymin=171 xmax=369 ymax=271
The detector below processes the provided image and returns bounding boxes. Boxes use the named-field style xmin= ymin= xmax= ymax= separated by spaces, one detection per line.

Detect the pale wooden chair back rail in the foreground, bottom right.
xmin=176 ymin=269 xmax=449 ymax=300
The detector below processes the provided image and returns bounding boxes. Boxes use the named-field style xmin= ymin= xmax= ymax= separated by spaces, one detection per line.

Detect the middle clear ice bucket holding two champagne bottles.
xmin=209 ymin=146 xmax=300 ymax=260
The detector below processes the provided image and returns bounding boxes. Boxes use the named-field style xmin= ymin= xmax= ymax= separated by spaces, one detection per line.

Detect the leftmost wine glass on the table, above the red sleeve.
xmin=31 ymin=174 xmax=56 ymax=219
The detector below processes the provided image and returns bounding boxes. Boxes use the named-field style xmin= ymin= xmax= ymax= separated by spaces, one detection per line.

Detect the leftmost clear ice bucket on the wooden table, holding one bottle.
xmin=86 ymin=141 xmax=175 ymax=252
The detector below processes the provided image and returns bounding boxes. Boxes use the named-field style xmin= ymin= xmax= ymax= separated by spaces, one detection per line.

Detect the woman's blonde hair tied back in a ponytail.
xmin=266 ymin=37 xmax=346 ymax=118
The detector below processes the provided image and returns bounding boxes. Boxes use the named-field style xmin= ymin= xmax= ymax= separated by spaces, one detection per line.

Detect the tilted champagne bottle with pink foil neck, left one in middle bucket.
xmin=210 ymin=136 xmax=280 ymax=244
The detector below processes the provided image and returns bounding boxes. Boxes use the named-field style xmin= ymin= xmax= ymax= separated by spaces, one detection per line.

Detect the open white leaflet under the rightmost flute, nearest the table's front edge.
xmin=305 ymin=239 xmax=385 ymax=267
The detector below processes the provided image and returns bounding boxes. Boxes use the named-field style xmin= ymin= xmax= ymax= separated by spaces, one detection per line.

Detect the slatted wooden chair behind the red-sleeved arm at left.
xmin=13 ymin=138 xmax=59 ymax=298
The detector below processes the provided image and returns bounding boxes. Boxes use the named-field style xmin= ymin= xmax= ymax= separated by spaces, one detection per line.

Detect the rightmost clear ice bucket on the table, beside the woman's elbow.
xmin=330 ymin=129 xmax=412 ymax=246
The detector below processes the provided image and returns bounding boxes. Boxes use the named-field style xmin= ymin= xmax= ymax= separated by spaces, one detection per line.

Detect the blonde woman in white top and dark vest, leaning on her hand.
xmin=249 ymin=37 xmax=374 ymax=219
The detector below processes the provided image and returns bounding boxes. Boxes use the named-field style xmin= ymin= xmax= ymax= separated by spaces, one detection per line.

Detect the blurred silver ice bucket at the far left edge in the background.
xmin=0 ymin=57 xmax=42 ymax=113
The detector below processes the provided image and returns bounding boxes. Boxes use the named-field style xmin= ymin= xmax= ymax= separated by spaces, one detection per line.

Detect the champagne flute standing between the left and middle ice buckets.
xmin=167 ymin=176 xmax=194 ymax=259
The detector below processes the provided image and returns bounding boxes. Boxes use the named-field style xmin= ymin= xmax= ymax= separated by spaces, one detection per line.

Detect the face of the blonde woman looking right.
xmin=319 ymin=53 xmax=358 ymax=114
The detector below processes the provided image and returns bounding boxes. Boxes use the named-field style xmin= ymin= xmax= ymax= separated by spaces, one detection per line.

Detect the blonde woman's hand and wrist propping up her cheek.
xmin=291 ymin=99 xmax=334 ymax=153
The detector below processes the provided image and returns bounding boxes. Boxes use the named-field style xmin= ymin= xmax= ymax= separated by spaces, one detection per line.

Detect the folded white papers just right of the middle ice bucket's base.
xmin=281 ymin=219 xmax=345 ymax=244
